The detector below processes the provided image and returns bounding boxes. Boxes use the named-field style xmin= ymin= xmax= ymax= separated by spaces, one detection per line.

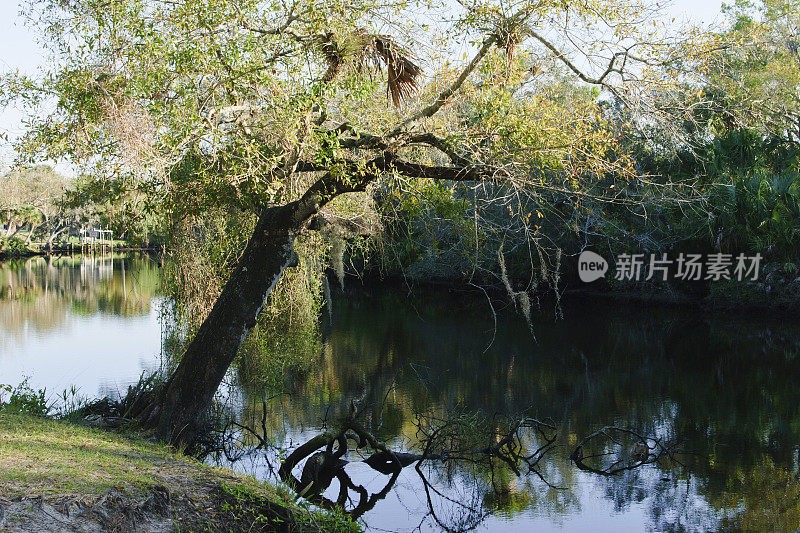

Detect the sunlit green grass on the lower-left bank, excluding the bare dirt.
xmin=0 ymin=412 xmax=360 ymax=532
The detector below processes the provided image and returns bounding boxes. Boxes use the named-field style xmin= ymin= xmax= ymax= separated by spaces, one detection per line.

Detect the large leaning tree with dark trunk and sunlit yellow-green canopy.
xmin=2 ymin=0 xmax=684 ymax=444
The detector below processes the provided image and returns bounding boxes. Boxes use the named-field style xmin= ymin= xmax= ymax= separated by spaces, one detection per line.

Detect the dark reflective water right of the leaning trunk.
xmin=227 ymin=293 xmax=800 ymax=531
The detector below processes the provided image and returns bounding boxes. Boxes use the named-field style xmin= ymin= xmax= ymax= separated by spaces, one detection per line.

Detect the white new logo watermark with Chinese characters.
xmin=578 ymin=250 xmax=761 ymax=283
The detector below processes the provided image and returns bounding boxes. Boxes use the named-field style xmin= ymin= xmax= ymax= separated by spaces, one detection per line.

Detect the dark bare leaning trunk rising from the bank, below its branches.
xmin=149 ymin=204 xmax=299 ymax=445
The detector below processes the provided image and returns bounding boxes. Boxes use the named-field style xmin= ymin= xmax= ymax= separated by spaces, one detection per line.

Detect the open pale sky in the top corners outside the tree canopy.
xmin=0 ymin=0 xmax=722 ymax=168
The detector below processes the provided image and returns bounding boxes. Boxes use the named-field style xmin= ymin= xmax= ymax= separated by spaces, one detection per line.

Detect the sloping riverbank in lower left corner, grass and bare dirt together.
xmin=0 ymin=413 xmax=359 ymax=532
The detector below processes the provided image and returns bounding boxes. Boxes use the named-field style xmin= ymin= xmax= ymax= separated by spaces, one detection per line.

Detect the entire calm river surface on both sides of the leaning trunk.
xmin=0 ymin=257 xmax=800 ymax=531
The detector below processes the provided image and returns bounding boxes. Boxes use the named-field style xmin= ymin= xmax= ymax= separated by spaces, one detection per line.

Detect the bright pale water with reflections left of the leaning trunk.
xmin=0 ymin=254 xmax=160 ymax=397
